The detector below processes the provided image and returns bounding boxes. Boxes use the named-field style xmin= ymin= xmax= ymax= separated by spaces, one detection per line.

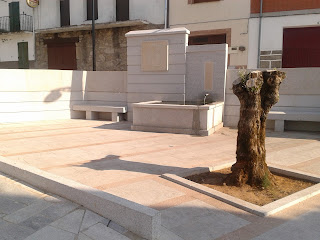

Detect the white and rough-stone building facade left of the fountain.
xmin=0 ymin=0 xmax=165 ymax=71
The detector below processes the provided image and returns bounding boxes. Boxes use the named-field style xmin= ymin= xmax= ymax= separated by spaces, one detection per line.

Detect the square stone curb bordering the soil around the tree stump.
xmin=162 ymin=163 xmax=320 ymax=217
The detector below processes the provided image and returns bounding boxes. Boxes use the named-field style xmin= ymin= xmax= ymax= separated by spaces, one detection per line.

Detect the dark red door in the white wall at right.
xmin=282 ymin=27 xmax=320 ymax=68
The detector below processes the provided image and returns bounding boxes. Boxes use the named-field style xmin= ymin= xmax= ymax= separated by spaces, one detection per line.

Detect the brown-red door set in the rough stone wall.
xmin=48 ymin=42 xmax=77 ymax=70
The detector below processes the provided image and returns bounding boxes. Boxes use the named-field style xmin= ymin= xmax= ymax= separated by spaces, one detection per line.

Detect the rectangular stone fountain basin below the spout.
xmin=131 ymin=101 xmax=224 ymax=136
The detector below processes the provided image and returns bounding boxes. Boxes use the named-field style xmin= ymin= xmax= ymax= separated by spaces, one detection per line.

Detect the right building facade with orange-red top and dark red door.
xmin=248 ymin=0 xmax=320 ymax=68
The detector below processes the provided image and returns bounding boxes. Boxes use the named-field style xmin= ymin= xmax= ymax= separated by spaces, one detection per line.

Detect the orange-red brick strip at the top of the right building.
xmin=251 ymin=0 xmax=320 ymax=13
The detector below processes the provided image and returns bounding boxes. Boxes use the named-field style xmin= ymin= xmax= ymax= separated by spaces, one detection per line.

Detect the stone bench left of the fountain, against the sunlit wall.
xmin=72 ymin=104 xmax=127 ymax=122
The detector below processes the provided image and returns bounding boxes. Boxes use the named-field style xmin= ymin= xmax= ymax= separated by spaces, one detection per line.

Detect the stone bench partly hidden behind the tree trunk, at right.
xmin=268 ymin=111 xmax=320 ymax=132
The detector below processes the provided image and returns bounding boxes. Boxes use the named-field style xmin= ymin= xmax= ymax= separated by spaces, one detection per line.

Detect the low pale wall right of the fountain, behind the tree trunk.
xmin=224 ymin=68 xmax=320 ymax=131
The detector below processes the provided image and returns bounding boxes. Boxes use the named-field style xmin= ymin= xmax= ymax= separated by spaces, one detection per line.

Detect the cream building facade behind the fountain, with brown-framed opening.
xmin=169 ymin=0 xmax=250 ymax=68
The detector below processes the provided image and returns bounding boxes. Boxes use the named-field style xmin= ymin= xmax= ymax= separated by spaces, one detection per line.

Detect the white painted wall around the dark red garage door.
xmin=248 ymin=14 xmax=320 ymax=68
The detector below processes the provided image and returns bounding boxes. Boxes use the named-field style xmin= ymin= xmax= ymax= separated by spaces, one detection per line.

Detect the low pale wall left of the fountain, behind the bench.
xmin=0 ymin=69 xmax=126 ymax=123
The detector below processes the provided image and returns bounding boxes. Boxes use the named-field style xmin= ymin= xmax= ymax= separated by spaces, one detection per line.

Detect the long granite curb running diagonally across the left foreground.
xmin=0 ymin=156 xmax=161 ymax=240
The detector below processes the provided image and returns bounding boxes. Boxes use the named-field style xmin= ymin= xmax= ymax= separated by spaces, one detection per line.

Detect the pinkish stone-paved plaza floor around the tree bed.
xmin=0 ymin=120 xmax=320 ymax=240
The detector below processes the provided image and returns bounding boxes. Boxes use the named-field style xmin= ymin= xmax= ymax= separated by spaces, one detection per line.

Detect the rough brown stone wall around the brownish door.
xmin=35 ymin=24 xmax=163 ymax=71
